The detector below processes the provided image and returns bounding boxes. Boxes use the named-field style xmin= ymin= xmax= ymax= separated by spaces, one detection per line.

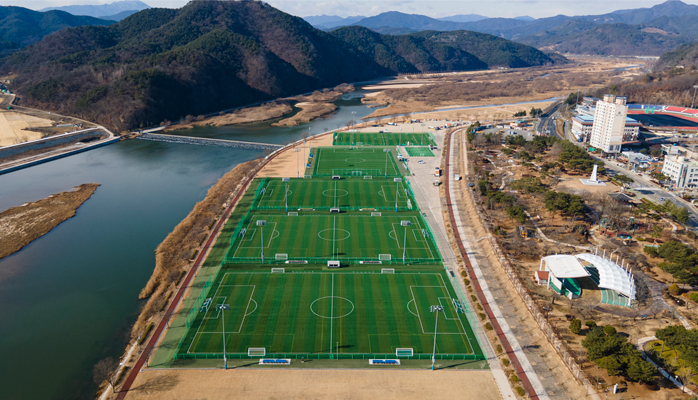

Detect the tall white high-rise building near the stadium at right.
xmin=589 ymin=94 xmax=628 ymax=153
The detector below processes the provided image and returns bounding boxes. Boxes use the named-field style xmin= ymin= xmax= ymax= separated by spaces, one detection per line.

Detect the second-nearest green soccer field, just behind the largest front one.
xmin=225 ymin=212 xmax=441 ymax=264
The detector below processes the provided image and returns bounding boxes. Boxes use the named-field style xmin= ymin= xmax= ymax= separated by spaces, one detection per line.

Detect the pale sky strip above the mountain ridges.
xmin=8 ymin=0 xmax=698 ymax=18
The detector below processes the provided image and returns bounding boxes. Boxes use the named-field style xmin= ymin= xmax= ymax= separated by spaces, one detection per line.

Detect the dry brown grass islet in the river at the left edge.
xmin=0 ymin=183 xmax=99 ymax=258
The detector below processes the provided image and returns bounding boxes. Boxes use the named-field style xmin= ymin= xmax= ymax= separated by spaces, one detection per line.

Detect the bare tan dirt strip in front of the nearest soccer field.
xmin=121 ymin=369 xmax=501 ymax=400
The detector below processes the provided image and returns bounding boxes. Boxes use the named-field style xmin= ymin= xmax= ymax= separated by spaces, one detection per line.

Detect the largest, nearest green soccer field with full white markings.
xmin=176 ymin=268 xmax=483 ymax=359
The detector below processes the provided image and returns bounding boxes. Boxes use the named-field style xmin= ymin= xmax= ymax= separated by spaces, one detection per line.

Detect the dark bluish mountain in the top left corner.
xmin=0 ymin=6 xmax=114 ymax=51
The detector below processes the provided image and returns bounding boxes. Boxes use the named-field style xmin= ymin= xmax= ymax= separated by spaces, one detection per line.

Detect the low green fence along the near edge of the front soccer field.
xmin=174 ymin=352 xmax=486 ymax=361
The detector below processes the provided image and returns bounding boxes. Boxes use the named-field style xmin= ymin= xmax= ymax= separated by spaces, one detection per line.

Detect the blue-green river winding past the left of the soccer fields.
xmin=0 ymin=92 xmax=373 ymax=400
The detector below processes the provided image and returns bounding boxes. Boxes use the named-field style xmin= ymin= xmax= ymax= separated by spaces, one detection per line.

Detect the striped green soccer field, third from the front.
xmin=252 ymin=177 xmax=417 ymax=211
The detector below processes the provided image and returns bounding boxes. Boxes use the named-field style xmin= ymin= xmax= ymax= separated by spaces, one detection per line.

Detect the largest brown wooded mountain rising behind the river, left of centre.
xmin=5 ymin=1 xmax=386 ymax=131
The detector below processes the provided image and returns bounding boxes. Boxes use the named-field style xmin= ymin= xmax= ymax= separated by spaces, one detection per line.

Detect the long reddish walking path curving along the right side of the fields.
xmin=444 ymin=133 xmax=539 ymax=399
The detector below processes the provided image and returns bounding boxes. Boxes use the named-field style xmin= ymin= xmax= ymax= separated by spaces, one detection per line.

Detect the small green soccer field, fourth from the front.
xmin=311 ymin=147 xmax=402 ymax=177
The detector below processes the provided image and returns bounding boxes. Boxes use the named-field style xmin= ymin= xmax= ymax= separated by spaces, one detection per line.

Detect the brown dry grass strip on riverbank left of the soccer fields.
xmin=131 ymin=159 xmax=261 ymax=337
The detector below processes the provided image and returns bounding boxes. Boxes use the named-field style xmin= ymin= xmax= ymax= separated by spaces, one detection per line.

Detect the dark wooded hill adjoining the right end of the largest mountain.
xmin=331 ymin=26 xmax=487 ymax=73
